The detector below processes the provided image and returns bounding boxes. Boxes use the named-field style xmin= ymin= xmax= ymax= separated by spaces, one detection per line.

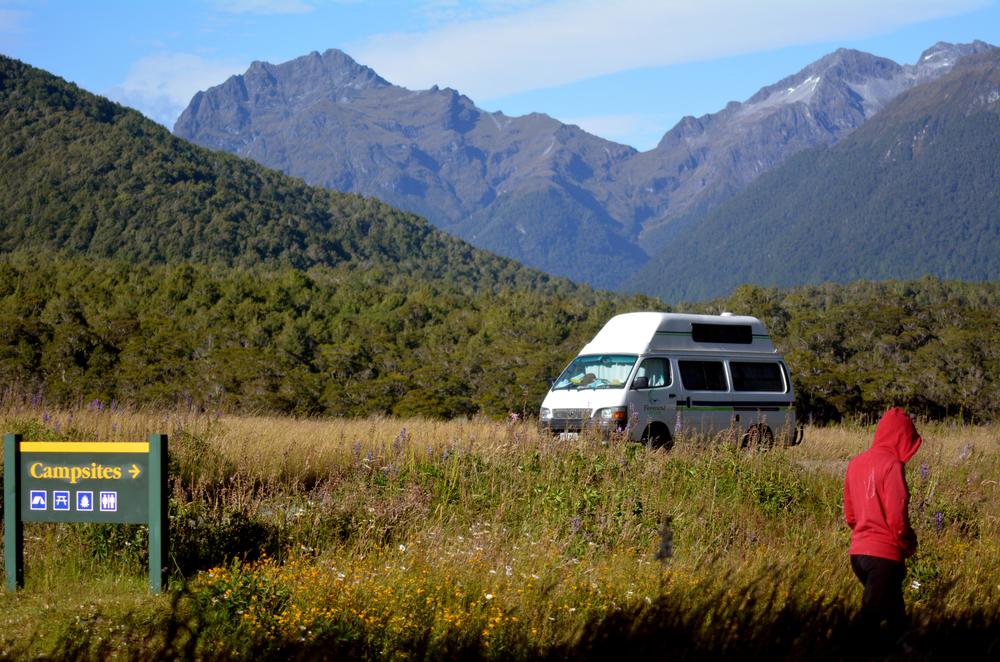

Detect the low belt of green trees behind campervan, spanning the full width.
xmin=0 ymin=253 xmax=1000 ymax=423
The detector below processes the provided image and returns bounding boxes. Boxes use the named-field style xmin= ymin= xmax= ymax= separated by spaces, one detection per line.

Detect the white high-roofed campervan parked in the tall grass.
xmin=538 ymin=313 xmax=801 ymax=447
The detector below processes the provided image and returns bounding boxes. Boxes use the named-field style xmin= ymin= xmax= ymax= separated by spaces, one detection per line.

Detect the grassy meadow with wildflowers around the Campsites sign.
xmin=0 ymin=397 xmax=1000 ymax=660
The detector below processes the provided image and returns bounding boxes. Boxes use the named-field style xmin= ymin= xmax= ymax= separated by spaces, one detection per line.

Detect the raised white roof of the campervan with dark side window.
xmin=580 ymin=313 xmax=778 ymax=355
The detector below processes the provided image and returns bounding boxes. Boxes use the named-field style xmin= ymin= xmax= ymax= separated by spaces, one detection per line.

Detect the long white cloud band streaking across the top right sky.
xmin=345 ymin=0 xmax=991 ymax=101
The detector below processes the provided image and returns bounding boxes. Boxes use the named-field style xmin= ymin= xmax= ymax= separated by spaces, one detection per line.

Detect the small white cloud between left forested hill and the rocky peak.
xmin=101 ymin=52 xmax=249 ymax=130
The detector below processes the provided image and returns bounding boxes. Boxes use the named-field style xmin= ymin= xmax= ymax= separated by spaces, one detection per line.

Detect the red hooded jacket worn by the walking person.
xmin=844 ymin=408 xmax=920 ymax=561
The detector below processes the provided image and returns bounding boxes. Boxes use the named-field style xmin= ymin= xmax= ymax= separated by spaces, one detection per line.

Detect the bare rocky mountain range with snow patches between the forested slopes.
xmin=174 ymin=41 xmax=992 ymax=288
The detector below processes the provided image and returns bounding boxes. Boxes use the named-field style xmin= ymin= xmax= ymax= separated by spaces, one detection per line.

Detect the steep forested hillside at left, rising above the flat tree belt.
xmin=0 ymin=56 xmax=576 ymax=292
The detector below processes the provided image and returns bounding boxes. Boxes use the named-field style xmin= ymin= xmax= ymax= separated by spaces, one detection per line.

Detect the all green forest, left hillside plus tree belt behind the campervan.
xmin=0 ymin=53 xmax=1000 ymax=422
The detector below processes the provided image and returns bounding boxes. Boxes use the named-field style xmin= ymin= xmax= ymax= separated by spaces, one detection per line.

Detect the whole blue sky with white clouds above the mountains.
xmin=0 ymin=0 xmax=1000 ymax=151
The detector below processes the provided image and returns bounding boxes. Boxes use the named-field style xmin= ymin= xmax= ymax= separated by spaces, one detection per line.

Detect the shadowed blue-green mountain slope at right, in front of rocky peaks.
xmin=623 ymin=49 xmax=1000 ymax=301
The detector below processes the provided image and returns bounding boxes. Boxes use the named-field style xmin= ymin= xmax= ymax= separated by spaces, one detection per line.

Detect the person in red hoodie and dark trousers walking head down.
xmin=844 ymin=407 xmax=921 ymax=633
